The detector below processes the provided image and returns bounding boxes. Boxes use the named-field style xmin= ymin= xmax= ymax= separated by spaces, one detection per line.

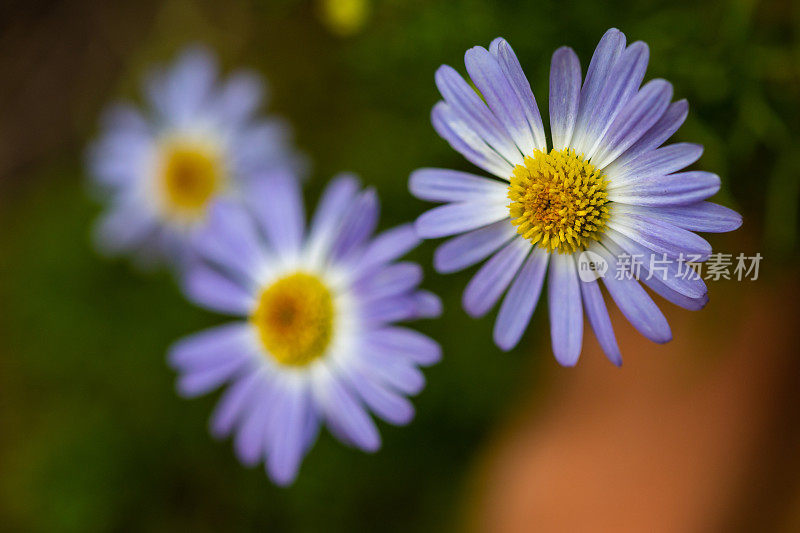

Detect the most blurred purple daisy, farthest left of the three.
xmin=88 ymin=47 xmax=300 ymax=261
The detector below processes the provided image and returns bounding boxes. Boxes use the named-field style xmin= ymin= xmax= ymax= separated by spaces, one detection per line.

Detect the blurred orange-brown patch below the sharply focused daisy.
xmin=470 ymin=273 xmax=800 ymax=533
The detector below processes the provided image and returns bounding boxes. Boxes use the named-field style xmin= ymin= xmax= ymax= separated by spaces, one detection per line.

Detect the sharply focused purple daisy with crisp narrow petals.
xmin=410 ymin=29 xmax=741 ymax=365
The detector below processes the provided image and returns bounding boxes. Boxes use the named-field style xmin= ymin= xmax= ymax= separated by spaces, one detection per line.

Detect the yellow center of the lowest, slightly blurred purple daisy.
xmin=250 ymin=272 xmax=334 ymax=366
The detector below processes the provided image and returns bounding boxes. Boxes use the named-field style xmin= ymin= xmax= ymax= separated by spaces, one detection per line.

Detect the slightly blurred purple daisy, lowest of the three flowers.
xmin=169 ymin=175 xmax=441 ymax=484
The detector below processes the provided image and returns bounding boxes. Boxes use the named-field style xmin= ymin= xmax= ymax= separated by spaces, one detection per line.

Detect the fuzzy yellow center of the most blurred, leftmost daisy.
xmin=161 ymin=141 xmax=224 ymax=218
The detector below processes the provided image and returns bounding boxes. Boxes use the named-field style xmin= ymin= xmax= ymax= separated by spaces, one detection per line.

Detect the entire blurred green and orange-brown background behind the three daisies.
xmin=0 ymin=0 xmax=800 ymax=532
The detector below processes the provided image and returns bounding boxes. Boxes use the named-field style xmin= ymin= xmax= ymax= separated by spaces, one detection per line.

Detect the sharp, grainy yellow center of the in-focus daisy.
xmin=508 ymin=148 xmax=610 ymax=253
